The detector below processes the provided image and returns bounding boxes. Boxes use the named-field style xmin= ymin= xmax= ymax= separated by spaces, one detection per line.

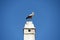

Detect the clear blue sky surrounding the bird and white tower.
xmin=0 ymin=0 xmax=60 ymax=40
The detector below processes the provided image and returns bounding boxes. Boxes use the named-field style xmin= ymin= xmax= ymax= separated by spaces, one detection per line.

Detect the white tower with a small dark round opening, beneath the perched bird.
xmin=24 ymin=21 xmax=35 ymax=40
